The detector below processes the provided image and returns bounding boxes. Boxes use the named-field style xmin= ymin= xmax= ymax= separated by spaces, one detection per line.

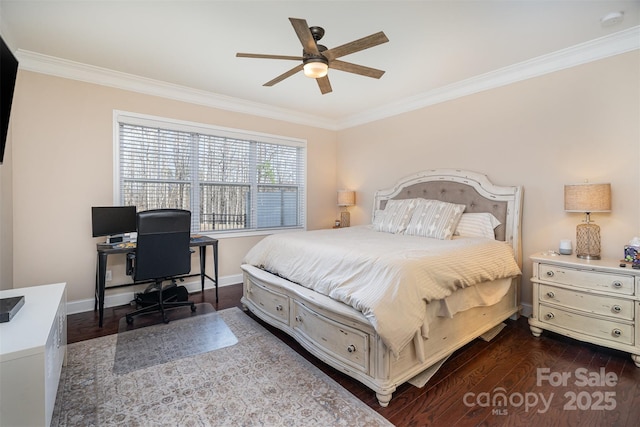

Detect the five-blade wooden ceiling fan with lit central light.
xmin=236 ymin=18 xmax=389 ymax=95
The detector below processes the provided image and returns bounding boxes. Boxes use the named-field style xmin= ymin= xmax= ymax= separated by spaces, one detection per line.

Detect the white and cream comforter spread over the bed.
xmin=244 ymin=226 xmax=521 ymax=355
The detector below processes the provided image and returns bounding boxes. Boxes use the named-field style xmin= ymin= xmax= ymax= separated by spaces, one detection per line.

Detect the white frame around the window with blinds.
xmin=113 ymin=110 xmax=308 ymax=238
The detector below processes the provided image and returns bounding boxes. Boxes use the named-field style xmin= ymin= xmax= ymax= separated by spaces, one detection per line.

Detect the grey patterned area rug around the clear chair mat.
xmin=51 ymin=308 xmax=391 ymax=426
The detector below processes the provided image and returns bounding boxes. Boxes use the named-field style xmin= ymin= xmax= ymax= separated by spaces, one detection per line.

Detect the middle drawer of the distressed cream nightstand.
xmin=539 ymin=284 xmax=635 ymax=321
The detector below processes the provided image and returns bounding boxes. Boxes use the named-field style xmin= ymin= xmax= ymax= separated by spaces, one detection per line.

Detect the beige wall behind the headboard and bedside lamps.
xmin=338 ymin=51 xmax=640 ymax=310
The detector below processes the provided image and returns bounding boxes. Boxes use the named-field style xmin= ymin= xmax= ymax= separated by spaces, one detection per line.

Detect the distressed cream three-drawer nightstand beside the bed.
xmin=529 ymin=253 xmax=640 ymax=367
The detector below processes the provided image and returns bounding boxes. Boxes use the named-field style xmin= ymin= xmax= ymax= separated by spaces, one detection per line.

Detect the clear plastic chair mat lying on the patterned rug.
xmin=113 ymin=304 xmax=238 ymax=375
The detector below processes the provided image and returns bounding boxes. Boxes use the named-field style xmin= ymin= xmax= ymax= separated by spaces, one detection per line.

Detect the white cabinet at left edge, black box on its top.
xmin=0 ymin=283 xmax=67 ymax=427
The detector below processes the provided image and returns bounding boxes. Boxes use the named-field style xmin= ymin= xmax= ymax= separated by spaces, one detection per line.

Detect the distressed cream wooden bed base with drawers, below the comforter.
xmin=242 ymin=265 xmax=518 ymax=406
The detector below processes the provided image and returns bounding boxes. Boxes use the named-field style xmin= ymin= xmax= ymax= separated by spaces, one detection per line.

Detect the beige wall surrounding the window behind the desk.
xmin=7 ymin=71 xmax=337 ymax=301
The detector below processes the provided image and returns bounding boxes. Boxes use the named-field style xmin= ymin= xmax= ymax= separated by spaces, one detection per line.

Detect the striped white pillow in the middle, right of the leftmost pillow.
xmin=405 ymin=199 xmax=465 ymax=240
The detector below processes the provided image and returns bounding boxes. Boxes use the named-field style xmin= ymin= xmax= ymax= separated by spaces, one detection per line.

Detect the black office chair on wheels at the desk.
xmin=126 ymin=209 xmax=196 ymax=324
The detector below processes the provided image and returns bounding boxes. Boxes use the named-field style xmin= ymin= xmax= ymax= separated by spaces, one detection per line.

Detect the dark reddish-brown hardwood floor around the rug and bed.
xmin=67 ymin=285 xmax=640 ymax=427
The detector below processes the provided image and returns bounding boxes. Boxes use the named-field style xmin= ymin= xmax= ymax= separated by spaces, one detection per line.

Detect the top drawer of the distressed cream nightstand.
xmin=538 ymin=263 xmax=634 ymax=295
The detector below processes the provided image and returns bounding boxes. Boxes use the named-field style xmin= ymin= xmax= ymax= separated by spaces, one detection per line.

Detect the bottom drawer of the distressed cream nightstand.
xmin=539 ymin=304 xmax=635 ymax=345
